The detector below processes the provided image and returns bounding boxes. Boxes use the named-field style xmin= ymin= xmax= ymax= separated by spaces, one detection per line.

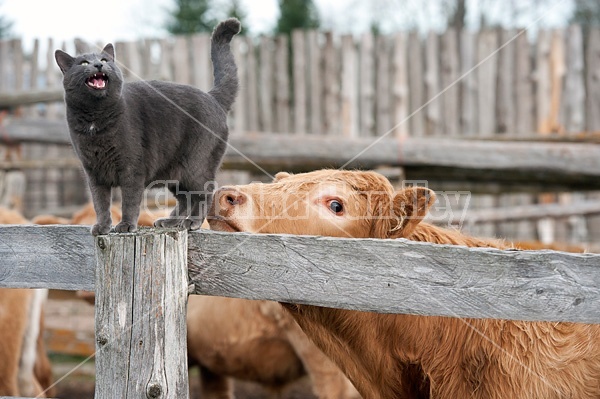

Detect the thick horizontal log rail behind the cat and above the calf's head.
xmin=3 ymin=120 xmax=600 ymax=180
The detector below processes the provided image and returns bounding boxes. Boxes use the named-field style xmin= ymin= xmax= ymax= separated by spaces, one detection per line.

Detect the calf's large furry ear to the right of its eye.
xmin=390 ymin=187 xmax=435 ymax=238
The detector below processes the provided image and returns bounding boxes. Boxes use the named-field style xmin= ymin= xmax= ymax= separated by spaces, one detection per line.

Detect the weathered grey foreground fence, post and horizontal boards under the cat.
xmin=0 ymin=226 xmax=600 ymax=399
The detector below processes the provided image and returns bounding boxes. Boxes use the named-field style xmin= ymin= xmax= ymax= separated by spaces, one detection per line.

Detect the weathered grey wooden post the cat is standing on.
xmin=95 ymin=229 xmax=189 ymax=399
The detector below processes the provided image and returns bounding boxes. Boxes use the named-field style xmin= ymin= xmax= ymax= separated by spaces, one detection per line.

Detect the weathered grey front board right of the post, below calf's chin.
xmin=188 ymin=232 xmax=600 ymax=323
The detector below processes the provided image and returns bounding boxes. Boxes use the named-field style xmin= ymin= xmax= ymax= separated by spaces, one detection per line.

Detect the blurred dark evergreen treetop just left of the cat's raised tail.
xmin=167 ymin=0 xmax=217 ymax=35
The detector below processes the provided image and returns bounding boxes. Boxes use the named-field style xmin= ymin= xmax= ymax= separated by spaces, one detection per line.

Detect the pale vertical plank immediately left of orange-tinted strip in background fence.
xmin=535 ymin=30 xmax=552 ymax=134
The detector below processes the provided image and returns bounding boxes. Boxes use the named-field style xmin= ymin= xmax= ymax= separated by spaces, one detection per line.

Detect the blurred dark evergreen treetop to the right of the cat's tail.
xmin=275 ymin=0 xmax=320 ymax=35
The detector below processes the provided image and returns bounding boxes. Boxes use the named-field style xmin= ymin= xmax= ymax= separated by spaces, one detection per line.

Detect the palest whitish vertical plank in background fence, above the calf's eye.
xmin=340 ymin=35 xmax=358 ymax=137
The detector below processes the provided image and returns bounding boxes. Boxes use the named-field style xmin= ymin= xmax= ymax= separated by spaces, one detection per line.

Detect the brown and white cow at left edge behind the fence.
xmin=0 ymin=207 xmax=54 ymax=397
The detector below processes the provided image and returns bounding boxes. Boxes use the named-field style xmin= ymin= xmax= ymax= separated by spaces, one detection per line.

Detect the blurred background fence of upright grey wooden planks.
xmin=0 ymin=26 xmax=600 ymax=244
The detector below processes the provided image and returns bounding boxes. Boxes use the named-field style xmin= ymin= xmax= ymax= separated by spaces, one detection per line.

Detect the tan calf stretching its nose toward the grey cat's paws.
xmin=208 ymin=170 xmax=600 ymax=399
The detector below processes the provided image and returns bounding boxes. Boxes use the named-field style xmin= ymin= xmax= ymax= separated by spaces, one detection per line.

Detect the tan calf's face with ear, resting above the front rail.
xmin=207 ymin=170 xmax=435 ymax=238
